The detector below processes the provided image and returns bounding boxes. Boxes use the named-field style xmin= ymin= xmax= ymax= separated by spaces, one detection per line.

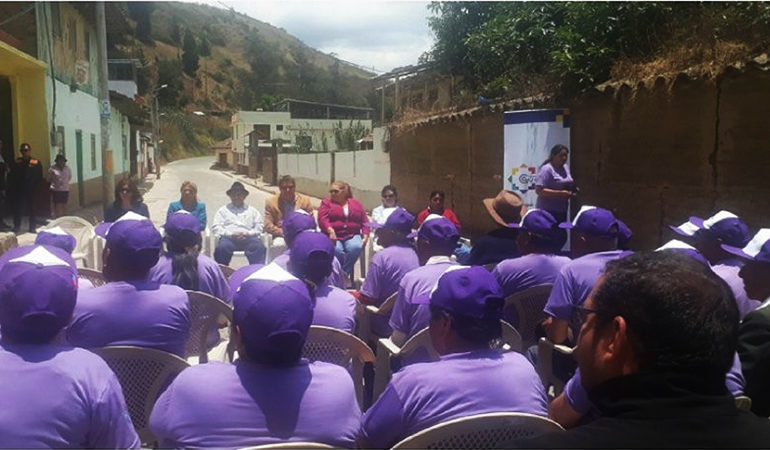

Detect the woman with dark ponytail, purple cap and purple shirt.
xmin=148 ymin=211 xmax=230 ymax=302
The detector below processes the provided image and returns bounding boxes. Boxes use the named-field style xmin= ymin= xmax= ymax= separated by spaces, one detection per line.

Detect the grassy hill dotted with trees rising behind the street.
xmin=110 ymin=2 xmax=378 ymax=160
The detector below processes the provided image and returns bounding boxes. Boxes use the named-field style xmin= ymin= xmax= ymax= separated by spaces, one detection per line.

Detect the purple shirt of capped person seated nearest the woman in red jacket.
xmin=361 ymin=245 xmax=420 ymax=337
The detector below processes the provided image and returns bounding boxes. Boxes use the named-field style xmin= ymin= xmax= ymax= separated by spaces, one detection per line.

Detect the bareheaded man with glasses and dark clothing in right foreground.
xmin=519 ymin=251 xmax=770 ymax=448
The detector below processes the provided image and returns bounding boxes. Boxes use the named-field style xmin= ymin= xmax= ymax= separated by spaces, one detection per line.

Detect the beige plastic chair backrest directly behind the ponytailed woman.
xmin=185 ymin=291 xmax=233 ymax=363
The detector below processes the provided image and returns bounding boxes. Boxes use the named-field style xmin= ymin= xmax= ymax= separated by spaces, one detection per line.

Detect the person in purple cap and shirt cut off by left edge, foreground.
xmin=0 ymin=246 xmax=140 ymax=448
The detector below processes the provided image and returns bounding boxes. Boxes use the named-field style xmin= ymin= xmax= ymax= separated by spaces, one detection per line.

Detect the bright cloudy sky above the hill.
xmin=196 ymin=0 xmax=433 ymax=72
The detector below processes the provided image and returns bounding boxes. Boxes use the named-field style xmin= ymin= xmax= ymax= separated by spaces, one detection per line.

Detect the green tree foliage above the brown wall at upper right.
xmin=423 ymin=2 xmax=770 ymax=95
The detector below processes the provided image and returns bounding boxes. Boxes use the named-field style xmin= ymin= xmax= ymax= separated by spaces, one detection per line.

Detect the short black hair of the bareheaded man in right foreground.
xmin=593 ymin=250 xmax=738 ymax=374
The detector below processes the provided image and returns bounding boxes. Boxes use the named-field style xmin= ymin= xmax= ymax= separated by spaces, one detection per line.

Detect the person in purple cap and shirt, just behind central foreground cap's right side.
xmin=289 ymin=231 xmax=356 ymax=333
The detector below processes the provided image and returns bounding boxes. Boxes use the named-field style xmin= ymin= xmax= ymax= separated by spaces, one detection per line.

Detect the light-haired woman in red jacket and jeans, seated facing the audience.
xmin=318 ymin=181 xmax=369 ymax=279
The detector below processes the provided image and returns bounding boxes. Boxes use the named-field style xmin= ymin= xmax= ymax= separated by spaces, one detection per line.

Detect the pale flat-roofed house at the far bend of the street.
xmin=230 ymin=99 xmax=373 ymax=176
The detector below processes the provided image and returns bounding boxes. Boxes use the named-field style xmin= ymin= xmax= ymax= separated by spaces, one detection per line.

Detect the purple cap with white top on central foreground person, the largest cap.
xmin=233 ymin=264 xmax=313 ymax=353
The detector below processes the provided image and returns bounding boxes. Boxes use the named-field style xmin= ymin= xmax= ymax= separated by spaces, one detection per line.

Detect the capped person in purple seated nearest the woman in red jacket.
xmin=354 ymin=207 xmax=420 ymax=337
